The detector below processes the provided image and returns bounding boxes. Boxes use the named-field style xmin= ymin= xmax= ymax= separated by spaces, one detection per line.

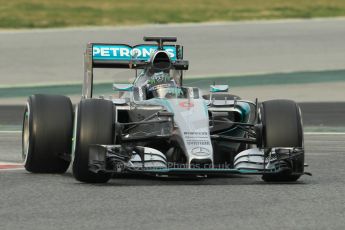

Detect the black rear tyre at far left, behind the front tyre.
xmin=22 ymin=94 xmax=73 ymax=173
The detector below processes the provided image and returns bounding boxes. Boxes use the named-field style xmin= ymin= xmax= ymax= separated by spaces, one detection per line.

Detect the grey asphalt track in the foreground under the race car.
xmin=0 ymin=133 xmax=345 ymax=230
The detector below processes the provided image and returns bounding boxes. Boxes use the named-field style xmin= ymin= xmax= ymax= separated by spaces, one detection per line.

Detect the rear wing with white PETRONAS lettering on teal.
xmin=82 ymin=43 xmax=188 ymax=98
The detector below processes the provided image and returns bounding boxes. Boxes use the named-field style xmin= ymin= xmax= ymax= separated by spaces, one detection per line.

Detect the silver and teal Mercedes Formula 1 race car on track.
xmin=22 ymin=37 xmax=305 ymax=183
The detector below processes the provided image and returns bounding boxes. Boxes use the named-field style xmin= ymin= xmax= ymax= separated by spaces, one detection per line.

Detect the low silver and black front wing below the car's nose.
xmin=89 ymin=145 xmax=305 ymax=176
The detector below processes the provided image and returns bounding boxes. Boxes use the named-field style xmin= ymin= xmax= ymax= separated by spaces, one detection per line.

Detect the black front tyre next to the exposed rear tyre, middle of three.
xmin=73 ymin=99 xmax=114 ymax=183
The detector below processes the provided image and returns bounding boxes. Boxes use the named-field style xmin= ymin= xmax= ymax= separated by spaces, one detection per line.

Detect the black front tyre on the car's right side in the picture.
xmin=260 ymin=100 xmax=304 ymax=182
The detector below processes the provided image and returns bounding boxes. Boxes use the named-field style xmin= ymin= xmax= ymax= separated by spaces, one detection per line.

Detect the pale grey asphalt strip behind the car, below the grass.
xmin=0 ymin=18 xmax=345 ymax=85
